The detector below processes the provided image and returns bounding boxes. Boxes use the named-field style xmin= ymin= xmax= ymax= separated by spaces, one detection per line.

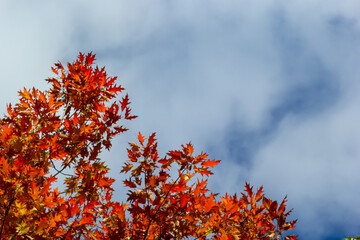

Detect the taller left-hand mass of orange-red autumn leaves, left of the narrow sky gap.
xmin=0 ymin=53 xmax=135 ymax=239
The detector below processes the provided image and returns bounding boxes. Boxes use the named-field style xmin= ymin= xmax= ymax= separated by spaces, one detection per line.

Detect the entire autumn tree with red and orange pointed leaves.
xmin=0 ymin=53 xmax=297 ymax=239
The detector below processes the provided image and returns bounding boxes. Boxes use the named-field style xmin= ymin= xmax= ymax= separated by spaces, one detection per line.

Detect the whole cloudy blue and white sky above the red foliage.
xmin=0 ymin=0 xmax=360 ymax=240
